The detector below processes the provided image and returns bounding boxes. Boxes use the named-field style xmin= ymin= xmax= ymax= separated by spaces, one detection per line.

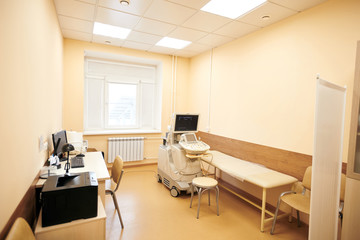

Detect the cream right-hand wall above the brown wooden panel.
xmin=189 ymin=0 xmax=360 ymax=162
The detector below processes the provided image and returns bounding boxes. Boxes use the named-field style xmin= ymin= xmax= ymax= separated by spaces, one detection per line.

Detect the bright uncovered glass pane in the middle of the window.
xmin=108 ymin=83 xmax=137 ymax=127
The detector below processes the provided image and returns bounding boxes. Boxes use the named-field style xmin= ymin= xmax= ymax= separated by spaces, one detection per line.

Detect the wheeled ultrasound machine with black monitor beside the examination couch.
xmin=158 ymin=114 xmax=210 ymax=197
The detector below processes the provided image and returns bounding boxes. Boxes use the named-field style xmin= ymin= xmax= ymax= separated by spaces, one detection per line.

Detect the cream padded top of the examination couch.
xmin=201 ymin=151 xmax=297 ymax=188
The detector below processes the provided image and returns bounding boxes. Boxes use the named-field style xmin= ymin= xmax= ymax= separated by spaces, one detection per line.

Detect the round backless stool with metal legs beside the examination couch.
xmin=190 ymin=177 xmax=219 ymax=218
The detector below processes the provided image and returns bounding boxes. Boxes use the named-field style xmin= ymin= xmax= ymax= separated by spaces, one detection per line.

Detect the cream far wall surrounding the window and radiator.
xmin=63 ymin=39 xmax=189 ymax=162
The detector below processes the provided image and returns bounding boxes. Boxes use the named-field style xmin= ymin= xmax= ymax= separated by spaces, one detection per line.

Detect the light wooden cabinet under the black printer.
xmin=35 ymin=197 xmax=106 ymax=240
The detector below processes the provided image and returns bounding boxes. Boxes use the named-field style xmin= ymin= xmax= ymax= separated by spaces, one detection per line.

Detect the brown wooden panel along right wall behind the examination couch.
xmin=197 ymin=132 xmax=312 ymax=181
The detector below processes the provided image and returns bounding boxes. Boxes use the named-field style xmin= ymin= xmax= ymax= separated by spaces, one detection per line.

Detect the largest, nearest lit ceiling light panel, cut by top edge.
xmin=201 ymin=0 xmax=266 ymax=19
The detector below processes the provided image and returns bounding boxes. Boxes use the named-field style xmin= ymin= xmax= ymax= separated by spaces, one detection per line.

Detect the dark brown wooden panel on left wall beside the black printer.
xmin=0 ymin=171 xmax=40 ymax=240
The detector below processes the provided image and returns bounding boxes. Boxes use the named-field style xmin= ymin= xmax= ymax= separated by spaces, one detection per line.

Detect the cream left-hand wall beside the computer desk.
xmin=0 ymin=0 xmax=63 ymax=230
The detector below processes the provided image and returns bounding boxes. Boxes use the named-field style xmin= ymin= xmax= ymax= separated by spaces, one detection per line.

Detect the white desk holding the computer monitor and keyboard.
xmin=36 ymin=152 xmax=110 ymax=206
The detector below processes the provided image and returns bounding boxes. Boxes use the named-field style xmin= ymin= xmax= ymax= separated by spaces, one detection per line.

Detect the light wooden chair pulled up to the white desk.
xmin=105 ymin=156 xmax=124 ymax=228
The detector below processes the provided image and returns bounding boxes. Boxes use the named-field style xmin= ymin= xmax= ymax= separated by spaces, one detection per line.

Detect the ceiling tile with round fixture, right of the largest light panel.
xmin=237 ymin=2 xmax=297 ymax=27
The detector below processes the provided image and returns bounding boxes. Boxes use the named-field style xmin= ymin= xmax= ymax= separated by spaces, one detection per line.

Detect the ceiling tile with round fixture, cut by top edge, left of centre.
xmin=99 ymin=0 xmax=152 ymax=16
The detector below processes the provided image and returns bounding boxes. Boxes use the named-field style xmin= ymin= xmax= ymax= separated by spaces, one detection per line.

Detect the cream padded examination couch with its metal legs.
xmin=201 ymin=151 xmax=298 ymax=232
